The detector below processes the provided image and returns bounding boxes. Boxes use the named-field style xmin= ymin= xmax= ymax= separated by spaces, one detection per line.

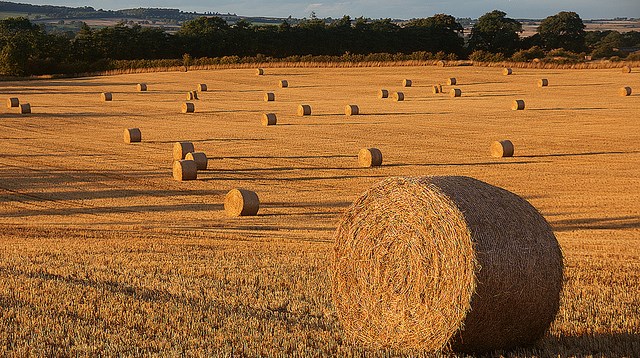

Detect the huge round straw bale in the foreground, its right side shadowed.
xmin=331 ymin=176 xmax=563 ymax=352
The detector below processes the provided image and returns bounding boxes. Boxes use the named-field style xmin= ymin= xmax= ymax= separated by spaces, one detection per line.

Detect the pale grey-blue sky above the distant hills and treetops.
xmin=25 ymin=0 xmax=640 ymax=19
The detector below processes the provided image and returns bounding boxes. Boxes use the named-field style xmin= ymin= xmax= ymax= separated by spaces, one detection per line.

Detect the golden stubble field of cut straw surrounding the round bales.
xmin=0 ymin=67 xmax=640 ymax=356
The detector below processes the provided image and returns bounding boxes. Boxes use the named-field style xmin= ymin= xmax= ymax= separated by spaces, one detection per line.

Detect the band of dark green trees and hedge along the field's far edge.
xmin=0 ymin=10 xmax=640 ymax=76
